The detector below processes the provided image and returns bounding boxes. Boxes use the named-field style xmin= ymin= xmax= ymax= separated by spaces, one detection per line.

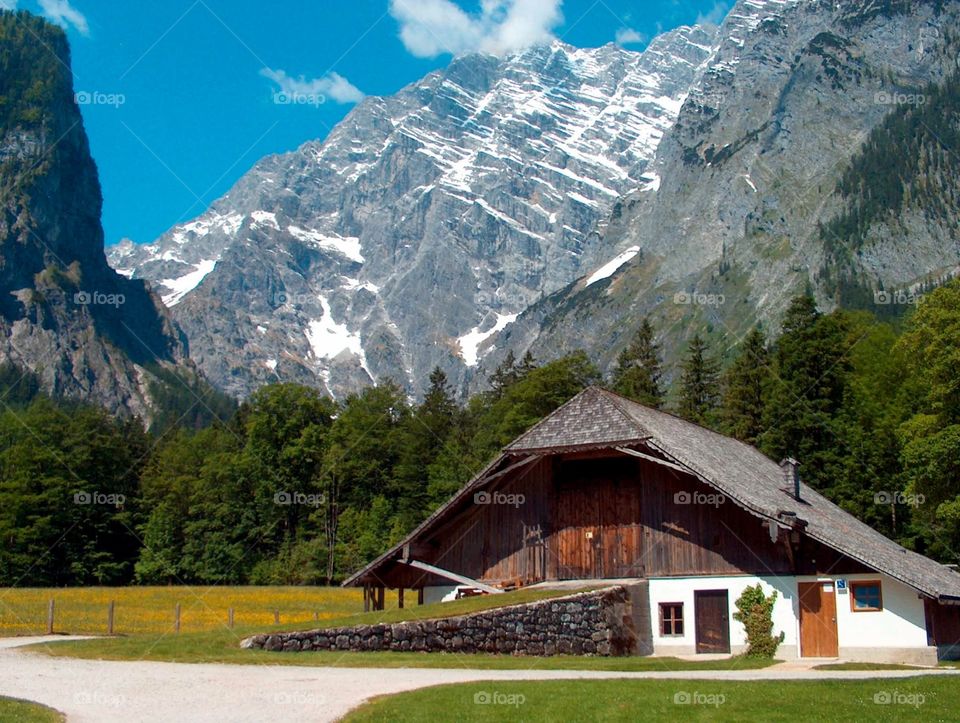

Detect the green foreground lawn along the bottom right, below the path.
xmin=345 ymin=677 xmax=960 ymax=723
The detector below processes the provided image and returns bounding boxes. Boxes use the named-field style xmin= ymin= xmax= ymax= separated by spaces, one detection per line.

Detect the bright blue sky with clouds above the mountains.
xmin=0 ymin=0 xmax=727 ymax=244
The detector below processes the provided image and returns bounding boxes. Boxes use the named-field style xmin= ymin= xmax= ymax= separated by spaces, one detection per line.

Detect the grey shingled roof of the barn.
xmin=344 ymin=387 xmax=960 ymax=602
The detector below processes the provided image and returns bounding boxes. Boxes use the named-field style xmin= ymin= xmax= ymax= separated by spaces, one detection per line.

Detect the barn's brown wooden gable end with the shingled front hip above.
xmin=346 ymin=390 xmax=866 ymax=589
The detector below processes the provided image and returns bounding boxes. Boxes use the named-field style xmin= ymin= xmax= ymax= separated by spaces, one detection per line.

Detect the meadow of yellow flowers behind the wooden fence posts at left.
xmin=0 ymin=587 xmax=376 ymax=636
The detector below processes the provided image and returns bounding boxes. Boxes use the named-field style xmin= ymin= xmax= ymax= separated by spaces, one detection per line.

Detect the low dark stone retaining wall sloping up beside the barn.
xmin=241 ymin=586 xmax=637 ymax=656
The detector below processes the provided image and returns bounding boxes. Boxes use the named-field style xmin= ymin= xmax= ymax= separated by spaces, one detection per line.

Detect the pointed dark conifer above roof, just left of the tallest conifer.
xmin=720 ymin=328 xmax=772 ymax=444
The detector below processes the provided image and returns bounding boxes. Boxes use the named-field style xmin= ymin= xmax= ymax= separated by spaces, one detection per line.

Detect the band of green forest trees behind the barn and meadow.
xmin=0 ymin=283 xmax=960 ymax=586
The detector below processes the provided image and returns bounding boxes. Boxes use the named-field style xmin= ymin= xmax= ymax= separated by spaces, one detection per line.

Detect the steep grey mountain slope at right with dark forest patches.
xmin=488 ymin=0 xmax=960 ymax=384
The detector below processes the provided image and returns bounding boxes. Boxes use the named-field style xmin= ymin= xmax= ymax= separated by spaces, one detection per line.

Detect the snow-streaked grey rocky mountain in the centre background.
xmin=109 ymin=28 xmax=717 ymax=396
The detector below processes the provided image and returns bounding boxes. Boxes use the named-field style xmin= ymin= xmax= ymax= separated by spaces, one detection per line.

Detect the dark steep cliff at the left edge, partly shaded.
xmin=0 ymin=12 xmax=196 ymax=421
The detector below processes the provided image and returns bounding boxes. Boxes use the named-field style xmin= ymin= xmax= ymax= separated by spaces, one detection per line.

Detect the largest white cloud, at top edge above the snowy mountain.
xmin=390 ymin=0 xmax=563 ymax=58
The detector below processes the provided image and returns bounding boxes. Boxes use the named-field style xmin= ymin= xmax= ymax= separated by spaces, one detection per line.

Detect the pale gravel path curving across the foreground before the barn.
xmin=0 ymin=636 xmax=950 ymax=723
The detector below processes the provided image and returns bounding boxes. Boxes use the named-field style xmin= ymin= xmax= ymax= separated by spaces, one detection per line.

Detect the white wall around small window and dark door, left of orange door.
xmin=650 ymin=575 xmax=798 ymax=658
